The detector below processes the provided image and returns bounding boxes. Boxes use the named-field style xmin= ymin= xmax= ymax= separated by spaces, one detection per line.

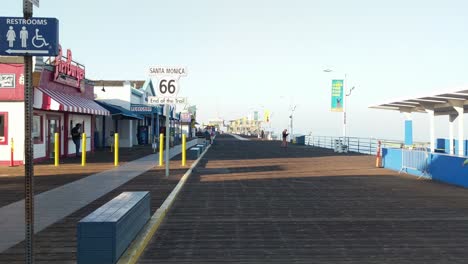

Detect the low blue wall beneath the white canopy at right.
xmin=382 ymin=148 xmax=468 ymax=187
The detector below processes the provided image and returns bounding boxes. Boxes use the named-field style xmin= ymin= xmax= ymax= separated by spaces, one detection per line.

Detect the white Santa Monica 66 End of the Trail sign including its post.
xmin=148 ymin=66 xmax=187 ymax=177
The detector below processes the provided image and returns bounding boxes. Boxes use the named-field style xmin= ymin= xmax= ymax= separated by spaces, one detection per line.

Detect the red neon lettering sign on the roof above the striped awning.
xmin=54 ymin=45 xmax=85 ymax=89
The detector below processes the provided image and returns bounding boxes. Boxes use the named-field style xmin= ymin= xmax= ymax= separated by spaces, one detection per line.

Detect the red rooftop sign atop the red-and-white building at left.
xmin=54 ymin=45 xmax=85 ymax=92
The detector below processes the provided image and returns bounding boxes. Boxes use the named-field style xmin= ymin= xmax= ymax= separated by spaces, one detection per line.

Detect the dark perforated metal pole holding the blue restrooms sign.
xmin=23 ymin=0 xmax=34 ymax=264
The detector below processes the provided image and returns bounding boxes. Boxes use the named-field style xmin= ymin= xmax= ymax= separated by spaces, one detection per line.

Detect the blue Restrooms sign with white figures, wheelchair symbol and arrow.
xmin=0 ymin=17 xmax=59 ymax=56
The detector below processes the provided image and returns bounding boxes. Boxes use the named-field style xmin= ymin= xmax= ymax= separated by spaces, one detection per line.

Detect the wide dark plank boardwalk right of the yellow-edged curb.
xmin=139 ymin=136 xmax=468 ymax=263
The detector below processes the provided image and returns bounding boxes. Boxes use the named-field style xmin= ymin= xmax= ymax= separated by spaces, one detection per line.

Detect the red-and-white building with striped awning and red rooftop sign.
xmin=0 ymin=50 xmax=110 ymax=165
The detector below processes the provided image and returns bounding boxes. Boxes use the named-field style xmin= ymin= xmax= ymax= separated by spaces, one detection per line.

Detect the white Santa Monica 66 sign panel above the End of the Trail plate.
xmin=149 ymin=66 xmax=187 ymax=97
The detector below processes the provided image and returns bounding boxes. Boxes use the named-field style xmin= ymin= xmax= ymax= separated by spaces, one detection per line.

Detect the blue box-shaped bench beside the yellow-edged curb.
xmin=77 ymin=192 xmax=151 ymax=264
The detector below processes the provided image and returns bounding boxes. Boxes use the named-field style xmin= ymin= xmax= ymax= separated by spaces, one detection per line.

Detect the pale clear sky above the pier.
xmin=0 ymin=0 xmax=468 ymax=140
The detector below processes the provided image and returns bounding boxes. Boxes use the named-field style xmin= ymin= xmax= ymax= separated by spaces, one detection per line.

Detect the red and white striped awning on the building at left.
xmin=34 ymin=87 xmax=110 ymax=115
